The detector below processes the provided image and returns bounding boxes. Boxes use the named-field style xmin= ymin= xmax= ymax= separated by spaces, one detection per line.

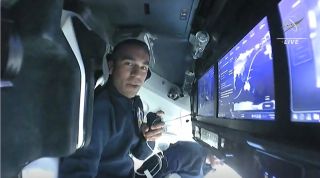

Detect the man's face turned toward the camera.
xmin=109 ymin=45 xmax=149 ymax=98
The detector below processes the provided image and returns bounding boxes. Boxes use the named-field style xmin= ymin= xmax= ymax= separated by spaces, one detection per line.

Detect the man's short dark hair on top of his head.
xmin=107 ymin=39 xmax=150 ymax=61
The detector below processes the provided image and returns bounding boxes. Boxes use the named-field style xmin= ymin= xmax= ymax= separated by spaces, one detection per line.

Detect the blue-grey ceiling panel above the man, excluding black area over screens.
xmin=64 ymin=0 xmax=199 ymax=86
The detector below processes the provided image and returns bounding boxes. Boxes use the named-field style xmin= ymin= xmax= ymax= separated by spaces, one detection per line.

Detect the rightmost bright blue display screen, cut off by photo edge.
xmin=279 ymin=0 xmax=320 ymax=123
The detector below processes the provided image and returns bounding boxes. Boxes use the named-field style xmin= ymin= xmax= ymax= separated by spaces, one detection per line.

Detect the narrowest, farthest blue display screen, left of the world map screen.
xmin=198 ymin=67 xmax=215 ymax=116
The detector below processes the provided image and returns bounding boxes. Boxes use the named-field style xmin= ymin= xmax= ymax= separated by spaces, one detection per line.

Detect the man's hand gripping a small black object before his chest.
xmin=141 ymin=122 xmax=164 ymax=141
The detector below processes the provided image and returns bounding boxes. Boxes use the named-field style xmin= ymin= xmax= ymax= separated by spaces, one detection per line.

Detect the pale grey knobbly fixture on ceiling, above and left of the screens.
xmin=189 ymin=31 xmax=210 ymax=59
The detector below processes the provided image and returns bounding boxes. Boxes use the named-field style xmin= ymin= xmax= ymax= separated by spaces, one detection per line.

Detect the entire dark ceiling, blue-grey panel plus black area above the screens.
xmin=64 ymin=0 xmax=279 ymax=86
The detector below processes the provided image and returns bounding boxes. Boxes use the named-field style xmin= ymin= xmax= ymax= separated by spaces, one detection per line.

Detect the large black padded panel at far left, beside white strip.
xmin=1 ymin=0 xmax=80 ymax=178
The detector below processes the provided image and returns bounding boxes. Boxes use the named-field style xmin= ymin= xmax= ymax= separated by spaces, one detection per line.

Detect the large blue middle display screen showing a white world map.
xmin=218 ymin=17 xmax=275 ymax=120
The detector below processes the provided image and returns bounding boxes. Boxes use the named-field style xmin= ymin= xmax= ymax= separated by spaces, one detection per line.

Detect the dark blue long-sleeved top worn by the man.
xmin=59 ymin=82 xmax=154 ymax=178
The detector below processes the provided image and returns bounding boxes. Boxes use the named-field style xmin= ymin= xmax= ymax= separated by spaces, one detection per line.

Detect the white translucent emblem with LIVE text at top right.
xmin=277 ymin=17 xmax=307 ymax=45
